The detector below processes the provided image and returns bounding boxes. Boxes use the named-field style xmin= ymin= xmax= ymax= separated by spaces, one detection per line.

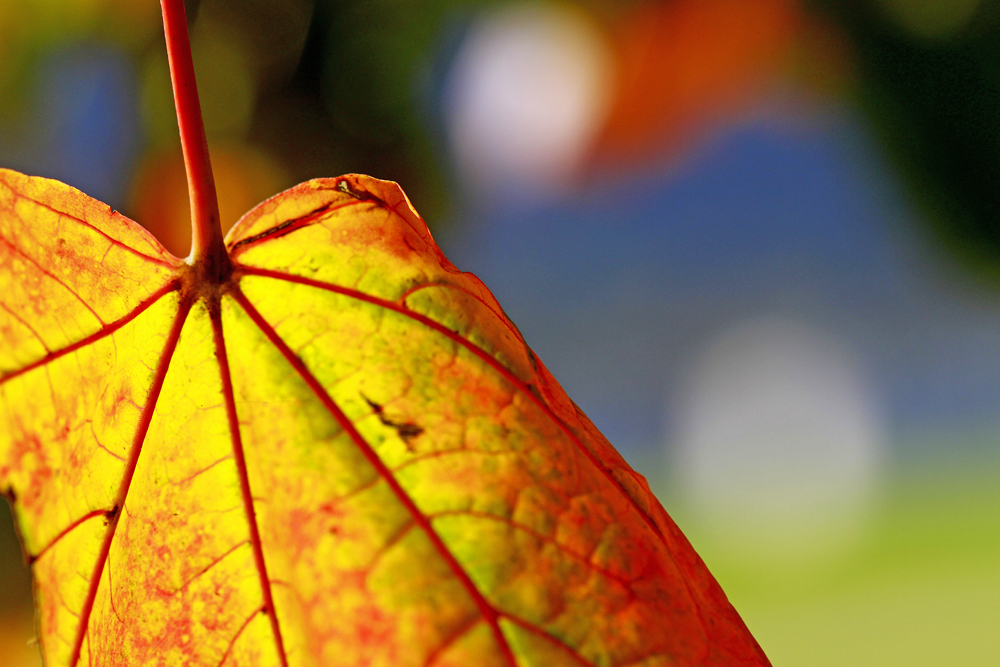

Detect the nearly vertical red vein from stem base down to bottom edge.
xmin=209 ymin=302 xmax=288 ymax=667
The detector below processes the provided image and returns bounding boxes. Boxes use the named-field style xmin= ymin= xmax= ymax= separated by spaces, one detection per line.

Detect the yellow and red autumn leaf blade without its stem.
xmin=0 ymin=171 xmax=768 ymax=667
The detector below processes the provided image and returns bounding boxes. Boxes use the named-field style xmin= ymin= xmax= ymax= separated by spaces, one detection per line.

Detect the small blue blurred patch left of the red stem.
xmin=0 ymin=45 xmax=142 ymax=209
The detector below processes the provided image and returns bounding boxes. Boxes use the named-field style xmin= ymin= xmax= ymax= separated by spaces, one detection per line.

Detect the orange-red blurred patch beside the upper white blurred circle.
xmin=593 ymin=0 xmax=803 ymax=163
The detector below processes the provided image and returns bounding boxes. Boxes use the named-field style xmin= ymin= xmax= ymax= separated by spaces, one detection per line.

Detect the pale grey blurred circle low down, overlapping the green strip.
xmin=674 ymin=318 xmax=885 ymax=564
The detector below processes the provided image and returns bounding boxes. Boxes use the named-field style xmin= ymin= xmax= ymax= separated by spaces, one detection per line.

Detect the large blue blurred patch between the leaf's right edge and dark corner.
xmin=440 ymin=110 xmax=1000 ymax=458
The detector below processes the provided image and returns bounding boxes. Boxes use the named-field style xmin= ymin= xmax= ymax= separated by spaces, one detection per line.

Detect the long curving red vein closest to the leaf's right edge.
xmin=240 ymin=266 xmax=666 ymax=543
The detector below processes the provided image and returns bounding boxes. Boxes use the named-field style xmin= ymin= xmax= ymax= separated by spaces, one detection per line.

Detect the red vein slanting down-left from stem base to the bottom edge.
xmin=69 ymin=300 xmax=191 ymax=667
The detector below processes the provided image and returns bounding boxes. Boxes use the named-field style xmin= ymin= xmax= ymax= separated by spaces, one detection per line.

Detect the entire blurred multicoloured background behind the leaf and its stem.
xmin=0 ymin=0 xmax=1000 ymax=667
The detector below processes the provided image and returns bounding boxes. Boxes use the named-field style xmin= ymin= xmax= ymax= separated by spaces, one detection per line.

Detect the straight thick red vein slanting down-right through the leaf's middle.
xmin=232 ymin=288 xmax=517 ymax=667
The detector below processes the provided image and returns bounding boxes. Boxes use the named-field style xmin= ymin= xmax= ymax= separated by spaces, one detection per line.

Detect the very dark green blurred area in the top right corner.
xmin=812 ymin=0 xmax=1000 ymax=284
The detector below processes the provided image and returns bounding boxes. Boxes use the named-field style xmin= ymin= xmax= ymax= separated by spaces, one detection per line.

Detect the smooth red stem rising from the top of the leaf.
xmin=160 ymin=0 xmax=232 ymax=283
